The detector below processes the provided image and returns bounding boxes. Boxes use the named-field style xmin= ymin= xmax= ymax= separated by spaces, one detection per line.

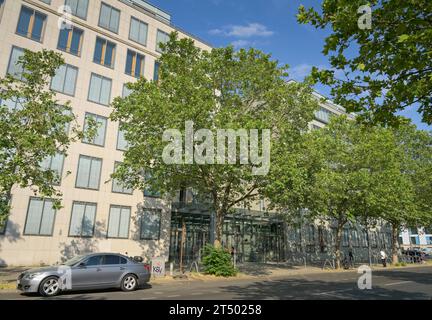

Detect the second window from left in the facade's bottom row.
xmin=69 ymin=202 xmax=96 ymax=237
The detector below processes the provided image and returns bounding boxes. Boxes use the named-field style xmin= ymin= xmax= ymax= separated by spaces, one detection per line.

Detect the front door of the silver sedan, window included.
xmin=72 ymin=255 xmax=103 ymax=290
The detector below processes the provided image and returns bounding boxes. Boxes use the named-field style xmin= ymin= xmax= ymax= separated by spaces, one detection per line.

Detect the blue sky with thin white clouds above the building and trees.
xmin=149 ymin=0 xmax=432 ymax=130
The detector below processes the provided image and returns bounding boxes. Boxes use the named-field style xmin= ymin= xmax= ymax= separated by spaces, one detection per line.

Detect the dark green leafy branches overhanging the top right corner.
xmin=297 ymin=0 xmax=432 ymax=124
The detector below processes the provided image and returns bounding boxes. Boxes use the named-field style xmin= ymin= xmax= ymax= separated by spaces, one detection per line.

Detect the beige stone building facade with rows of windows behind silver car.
xmin=0 ymin=0 xmax=210 ymax=266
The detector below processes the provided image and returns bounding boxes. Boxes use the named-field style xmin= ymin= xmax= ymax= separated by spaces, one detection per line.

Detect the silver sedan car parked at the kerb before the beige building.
xmin=17 ymin=253 xmax=150 ymax=297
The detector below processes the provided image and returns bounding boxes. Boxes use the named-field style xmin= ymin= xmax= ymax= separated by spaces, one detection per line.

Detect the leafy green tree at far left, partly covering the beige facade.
xmin=0 ymin=50 xmax=88 ymax=225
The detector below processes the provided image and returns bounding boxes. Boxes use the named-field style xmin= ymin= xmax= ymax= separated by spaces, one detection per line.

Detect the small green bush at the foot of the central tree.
xmin=203 ymin=245 xmax=237 ymax=277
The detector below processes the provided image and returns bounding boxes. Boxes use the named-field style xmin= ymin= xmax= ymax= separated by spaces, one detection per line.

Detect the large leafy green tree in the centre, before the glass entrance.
xmin=111 ymin=33 xmax=317 ymax=245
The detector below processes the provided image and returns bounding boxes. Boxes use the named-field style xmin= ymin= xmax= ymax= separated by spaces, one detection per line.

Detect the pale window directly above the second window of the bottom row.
xmin=75 ymin=155 xmax=102 ymax=190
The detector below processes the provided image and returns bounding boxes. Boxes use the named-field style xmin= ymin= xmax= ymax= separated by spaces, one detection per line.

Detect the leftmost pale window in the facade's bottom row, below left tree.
xmin=24 ymin=198 xmax=56 ymax=236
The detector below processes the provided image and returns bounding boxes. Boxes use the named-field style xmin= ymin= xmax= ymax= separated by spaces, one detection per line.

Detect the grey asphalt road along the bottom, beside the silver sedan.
xmin=0 ymin=266 xmax=432 ymax=300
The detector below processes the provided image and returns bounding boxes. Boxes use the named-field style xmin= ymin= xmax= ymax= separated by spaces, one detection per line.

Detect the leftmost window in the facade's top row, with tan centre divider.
xmin=17 ymin=7 xmax=47 ymax=42
